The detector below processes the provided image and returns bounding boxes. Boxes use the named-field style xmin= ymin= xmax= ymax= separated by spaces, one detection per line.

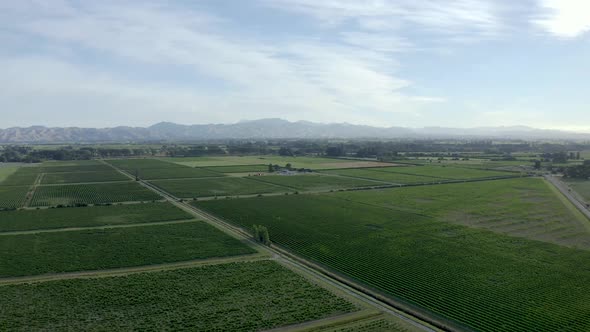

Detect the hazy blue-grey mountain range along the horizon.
xmin=0 ymin=119 xmax=590 ymax=143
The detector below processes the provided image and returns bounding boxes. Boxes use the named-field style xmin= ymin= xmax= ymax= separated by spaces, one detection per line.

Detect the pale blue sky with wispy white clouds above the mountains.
xmin=0 ymin=0 xmax=590 ymax=132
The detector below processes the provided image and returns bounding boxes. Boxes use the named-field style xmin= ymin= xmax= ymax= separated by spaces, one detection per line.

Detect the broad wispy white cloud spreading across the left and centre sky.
xmin=0 ymin=2 xmax=441 ymax=124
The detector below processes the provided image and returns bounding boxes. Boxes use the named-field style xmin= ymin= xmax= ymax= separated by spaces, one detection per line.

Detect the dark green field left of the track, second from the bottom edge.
xmin=0 ymin=221 xmax=255 ymax=277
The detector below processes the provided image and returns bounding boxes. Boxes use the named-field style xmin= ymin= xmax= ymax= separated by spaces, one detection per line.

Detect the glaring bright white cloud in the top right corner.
xmin=533 ymin=0 xmax=590 ymax=38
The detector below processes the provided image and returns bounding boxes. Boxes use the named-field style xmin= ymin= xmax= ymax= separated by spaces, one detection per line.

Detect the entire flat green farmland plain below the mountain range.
xmin=0 ymin=140 xmax=590 ymax=331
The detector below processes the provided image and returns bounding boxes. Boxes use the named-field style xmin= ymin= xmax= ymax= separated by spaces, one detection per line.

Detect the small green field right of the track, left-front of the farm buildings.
xmin=150 ymin=177 xmax=290 ymax=198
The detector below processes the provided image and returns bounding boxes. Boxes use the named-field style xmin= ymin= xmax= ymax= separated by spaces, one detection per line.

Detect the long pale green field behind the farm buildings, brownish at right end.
xmin=162 ymin=155 xmax=392 ymax=170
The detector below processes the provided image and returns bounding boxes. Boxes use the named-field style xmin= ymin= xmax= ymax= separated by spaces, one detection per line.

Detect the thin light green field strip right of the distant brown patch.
xmin=373 ymin=166 xmax=518 ymax=180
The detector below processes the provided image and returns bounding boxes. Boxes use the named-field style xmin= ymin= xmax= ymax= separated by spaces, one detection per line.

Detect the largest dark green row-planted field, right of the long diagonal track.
xmin=194 ymin=188 xmax=590 ymax=331
